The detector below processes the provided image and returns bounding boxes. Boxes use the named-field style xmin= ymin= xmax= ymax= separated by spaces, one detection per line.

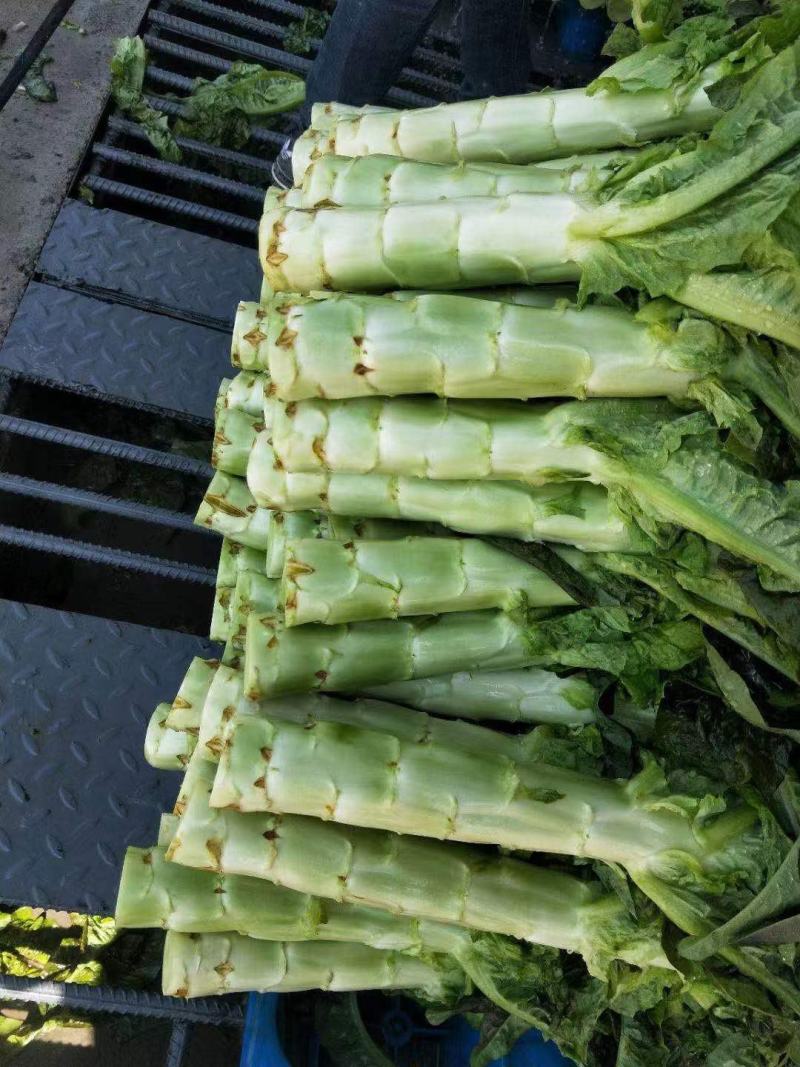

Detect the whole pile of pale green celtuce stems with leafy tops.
xmin=117 ymin=6 xmax=800 ymax=1067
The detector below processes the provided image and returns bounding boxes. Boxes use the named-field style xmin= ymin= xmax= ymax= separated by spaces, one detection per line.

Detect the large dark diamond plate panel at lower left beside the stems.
xmin=0 ymin=600 xmax=214 ymax=913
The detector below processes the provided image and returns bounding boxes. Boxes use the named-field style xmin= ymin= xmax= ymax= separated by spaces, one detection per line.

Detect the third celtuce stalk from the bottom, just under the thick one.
xmin=169 ymin=762 xmax=800 ymax=1012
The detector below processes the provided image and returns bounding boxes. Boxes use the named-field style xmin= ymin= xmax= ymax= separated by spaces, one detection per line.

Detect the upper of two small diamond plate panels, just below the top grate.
xmin=37 ymin=201 xmax=261 ymax=325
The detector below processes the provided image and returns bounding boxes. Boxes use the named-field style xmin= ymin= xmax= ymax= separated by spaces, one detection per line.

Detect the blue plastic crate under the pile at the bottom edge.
xmin=239 ymin=993 xmax=572 ymax=1067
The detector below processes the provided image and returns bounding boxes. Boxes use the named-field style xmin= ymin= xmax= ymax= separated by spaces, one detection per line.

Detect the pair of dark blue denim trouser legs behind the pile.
xmin=303 ymin=0 xmax=530 ymax=123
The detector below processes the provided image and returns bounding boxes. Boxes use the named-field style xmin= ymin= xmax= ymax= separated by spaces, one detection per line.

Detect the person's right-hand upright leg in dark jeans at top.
xmin=460 ymin=0 xmax=530 ymax=100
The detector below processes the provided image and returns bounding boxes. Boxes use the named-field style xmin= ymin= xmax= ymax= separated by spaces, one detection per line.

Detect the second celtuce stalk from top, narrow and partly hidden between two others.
xmin=288 ymin=154 xmax=607 ymax=208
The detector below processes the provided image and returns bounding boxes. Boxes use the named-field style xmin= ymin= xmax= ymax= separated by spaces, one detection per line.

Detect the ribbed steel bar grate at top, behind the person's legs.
xmin=75 ymin=0 xmax=596 ymax=248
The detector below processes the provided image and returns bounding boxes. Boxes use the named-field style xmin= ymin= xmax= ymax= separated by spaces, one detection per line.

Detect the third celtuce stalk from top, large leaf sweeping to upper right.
xmin=259 ymin=43 xmax=800 ymax=343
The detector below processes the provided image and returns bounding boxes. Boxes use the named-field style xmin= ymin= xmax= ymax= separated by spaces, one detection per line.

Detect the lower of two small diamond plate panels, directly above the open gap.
xmin=0 ymin=282 xmax=230 ymax=419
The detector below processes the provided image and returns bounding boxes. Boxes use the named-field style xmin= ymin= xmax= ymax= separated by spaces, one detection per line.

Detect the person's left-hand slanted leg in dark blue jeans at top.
xmin=304 ymin=0 xmax=439 ymax=118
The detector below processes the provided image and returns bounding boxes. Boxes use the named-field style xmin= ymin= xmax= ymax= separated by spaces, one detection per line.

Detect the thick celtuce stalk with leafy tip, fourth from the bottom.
xmin=210 ymin=718 xmax=800 ymax=1009
